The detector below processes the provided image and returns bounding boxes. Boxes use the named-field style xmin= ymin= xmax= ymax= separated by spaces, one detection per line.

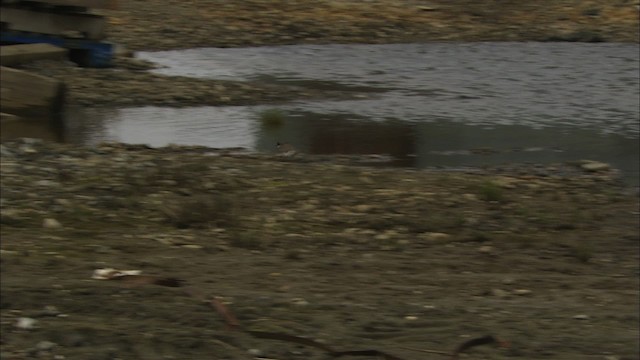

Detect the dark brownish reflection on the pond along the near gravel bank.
xmin=255 ymin=112 xmax=640 ymax=186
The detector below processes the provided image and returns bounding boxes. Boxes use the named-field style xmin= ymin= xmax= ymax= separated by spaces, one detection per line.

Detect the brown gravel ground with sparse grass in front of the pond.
xmin=0 ymin=141 xmax=640 ymax=360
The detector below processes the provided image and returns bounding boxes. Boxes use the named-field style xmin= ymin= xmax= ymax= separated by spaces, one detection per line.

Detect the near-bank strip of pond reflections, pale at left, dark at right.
xmin=60 ymin=106 xmax=640 ymax=186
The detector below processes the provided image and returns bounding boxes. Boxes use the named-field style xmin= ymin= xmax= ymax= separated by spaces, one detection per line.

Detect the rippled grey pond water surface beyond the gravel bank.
xmin=61 ymin=43 xmax=640 ymax=186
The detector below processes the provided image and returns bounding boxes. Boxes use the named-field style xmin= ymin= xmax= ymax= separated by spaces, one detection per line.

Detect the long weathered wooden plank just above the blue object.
xmin=0 ymin=7 xmax=107 ymax=40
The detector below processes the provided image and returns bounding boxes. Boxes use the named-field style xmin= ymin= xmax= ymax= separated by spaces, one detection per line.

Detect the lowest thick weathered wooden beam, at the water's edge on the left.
xmin=0 ymin=66 xmax=65 ymax=117
